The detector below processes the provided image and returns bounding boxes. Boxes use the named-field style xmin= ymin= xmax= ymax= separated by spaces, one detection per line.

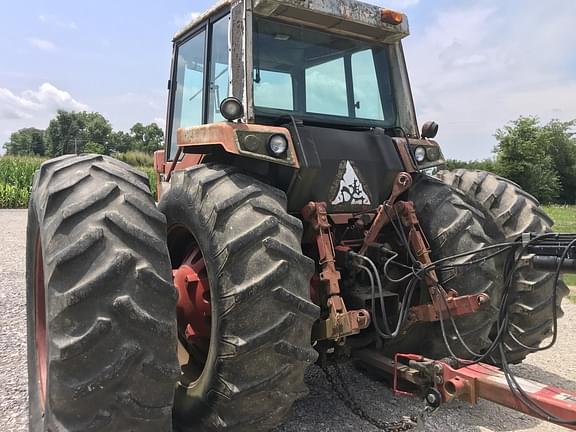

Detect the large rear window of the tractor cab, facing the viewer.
xmin=254 ymin=18 xmax=396 ymax=126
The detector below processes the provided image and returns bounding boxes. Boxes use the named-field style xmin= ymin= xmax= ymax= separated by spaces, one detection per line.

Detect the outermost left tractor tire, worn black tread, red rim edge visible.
xmin=26 ymin=155 xmax=179 ymax=432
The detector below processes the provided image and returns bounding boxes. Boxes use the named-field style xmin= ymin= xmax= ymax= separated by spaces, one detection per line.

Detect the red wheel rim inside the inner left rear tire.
xmin=172 ymin=230 xmax=212 ymax=381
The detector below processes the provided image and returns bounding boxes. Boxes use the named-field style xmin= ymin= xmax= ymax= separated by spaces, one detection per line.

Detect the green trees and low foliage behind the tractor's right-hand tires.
xmin=446 ymin=117 xmax=576 ymax=204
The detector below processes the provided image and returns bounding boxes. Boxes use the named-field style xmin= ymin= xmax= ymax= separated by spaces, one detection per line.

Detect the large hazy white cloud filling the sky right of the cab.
xmin=405 ymin=0 xmax=576 ymax=159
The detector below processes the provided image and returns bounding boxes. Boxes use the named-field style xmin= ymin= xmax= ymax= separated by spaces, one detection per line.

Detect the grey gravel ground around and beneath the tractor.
xmin=0 ymin=210 xmax=576 ymax=432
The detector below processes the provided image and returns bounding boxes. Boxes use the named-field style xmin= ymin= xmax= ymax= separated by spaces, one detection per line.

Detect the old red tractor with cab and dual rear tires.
xmin=27 ymin=0 xmax=574 ymax=432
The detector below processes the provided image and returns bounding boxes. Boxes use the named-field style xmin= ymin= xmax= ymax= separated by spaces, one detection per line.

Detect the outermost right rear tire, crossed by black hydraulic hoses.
xmin=437 ymin=169 xmax=570 ymax=363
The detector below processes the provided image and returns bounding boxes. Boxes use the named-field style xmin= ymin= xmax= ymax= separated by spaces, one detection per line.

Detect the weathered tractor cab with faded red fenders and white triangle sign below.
xmin=157 ymin=0 xmax=443 ymax=213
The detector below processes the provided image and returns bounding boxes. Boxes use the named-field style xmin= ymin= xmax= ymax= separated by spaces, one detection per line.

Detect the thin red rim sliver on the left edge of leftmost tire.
xmin=34 ymin=237 xmax=48 ymax=410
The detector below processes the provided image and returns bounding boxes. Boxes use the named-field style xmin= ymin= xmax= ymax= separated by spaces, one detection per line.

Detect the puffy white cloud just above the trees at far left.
xmin=0 ymin=83 xmax=88 ymax=147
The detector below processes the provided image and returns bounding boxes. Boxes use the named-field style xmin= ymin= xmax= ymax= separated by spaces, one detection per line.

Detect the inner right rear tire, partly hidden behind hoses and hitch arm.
xmin=385 ymin=175 xmax=503 ymax=358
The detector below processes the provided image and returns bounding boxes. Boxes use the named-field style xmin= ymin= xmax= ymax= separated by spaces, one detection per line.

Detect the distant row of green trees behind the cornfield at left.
xmin=4 ymin=111 xmax=164 ymax=157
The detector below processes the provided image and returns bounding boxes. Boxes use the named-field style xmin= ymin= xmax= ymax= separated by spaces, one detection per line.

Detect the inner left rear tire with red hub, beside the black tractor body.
xmin=159 ymin=165 xmax=319 ymax=431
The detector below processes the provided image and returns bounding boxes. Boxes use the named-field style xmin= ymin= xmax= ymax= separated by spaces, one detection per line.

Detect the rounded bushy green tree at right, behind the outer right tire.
xmin=495 ymin=117 xmax=561 ymax=202
